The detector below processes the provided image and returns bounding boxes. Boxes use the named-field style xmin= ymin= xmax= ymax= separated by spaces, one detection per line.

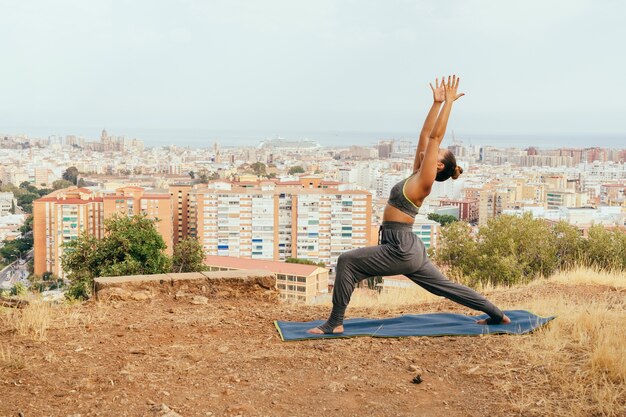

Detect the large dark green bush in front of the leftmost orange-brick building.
xmin=61 ymin=215 xmax=171 ymax=299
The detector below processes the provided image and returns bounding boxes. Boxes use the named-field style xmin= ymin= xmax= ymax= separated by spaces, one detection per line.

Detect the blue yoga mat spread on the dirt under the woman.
xmin=274 ymin=310 xmax=556 ymax=341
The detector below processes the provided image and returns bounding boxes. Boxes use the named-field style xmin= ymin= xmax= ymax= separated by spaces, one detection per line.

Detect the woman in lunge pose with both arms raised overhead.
xmin=308 ymin=75 xmax=511 ymax=334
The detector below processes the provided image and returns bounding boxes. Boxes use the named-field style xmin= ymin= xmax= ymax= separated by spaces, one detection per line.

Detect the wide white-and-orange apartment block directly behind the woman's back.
xmin=185 ymin=177 xmax=372 ymax=266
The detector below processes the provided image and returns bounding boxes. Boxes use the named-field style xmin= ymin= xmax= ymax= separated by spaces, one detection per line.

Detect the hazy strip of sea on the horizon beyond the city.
xmin=0 ymin=127 xmax=626 ymax=149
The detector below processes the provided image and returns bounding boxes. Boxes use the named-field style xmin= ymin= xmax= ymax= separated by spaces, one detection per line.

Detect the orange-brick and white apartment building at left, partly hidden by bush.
xmin=33 ymin=187 xmax=172 ymax=277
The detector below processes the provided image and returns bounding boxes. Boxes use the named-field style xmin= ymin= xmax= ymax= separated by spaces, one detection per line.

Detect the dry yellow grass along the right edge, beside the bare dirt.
xmin=502 ymin=270 xmax=626 ymax=417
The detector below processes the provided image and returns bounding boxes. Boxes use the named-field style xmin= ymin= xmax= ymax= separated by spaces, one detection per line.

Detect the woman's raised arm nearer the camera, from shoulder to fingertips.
xmin=407 ymin=76 xmax=464 ymax=203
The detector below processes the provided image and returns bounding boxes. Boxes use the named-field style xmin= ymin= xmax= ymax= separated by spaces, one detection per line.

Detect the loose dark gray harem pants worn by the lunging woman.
xmin=319 ymin=222 xmax=504 ymax=333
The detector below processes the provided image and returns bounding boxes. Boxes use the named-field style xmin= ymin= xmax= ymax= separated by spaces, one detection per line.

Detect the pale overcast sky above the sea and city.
xmin=0 ymin=0 xmax=626 ymax=134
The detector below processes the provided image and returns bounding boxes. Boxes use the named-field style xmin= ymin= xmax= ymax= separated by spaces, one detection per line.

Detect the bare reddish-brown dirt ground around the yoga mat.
xmin=0 ymin=285 xmax=616 ymax=417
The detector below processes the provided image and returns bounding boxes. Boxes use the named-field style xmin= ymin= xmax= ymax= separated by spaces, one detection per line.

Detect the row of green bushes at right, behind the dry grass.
xmin=435 ymin=214 xmax=626 ymax=285
